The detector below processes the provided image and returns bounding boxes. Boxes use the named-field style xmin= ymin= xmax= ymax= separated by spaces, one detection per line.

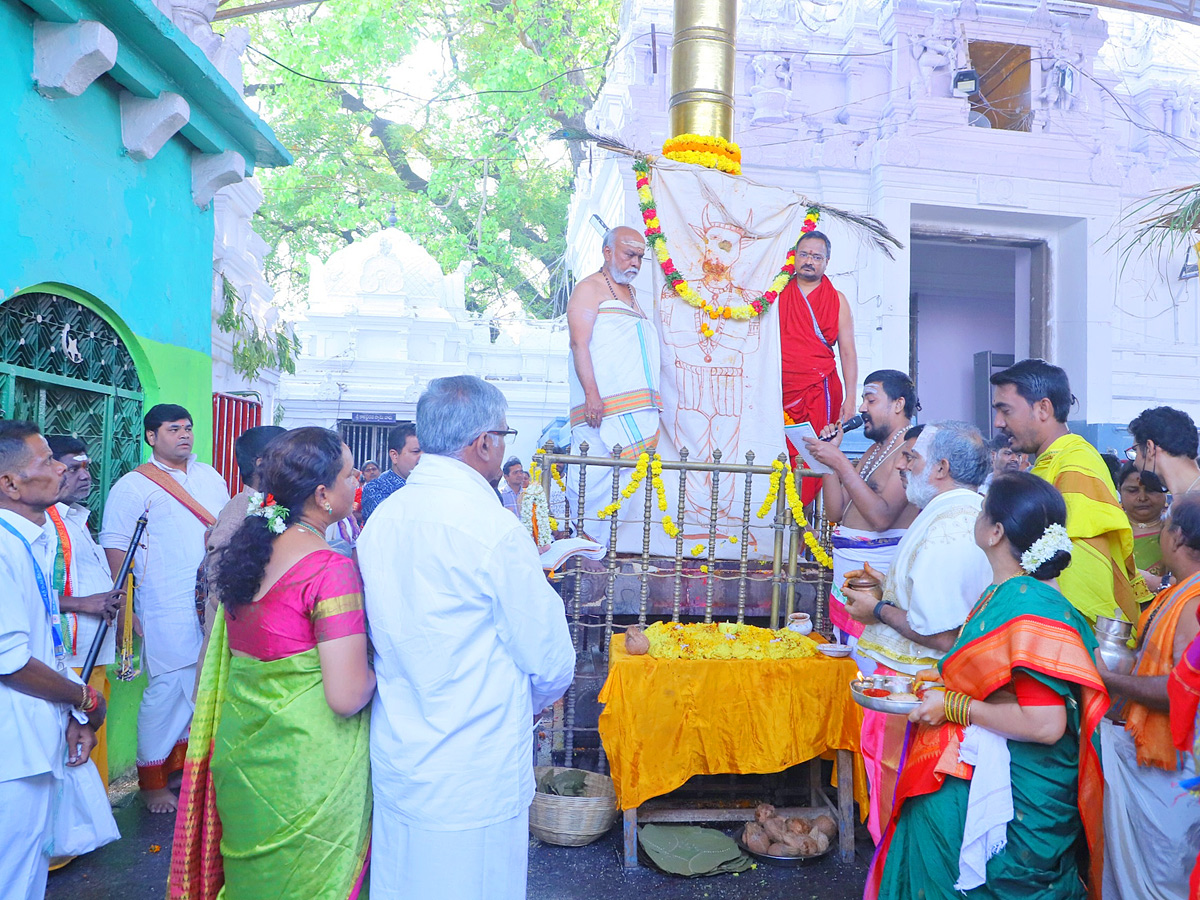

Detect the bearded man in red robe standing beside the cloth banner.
xmin=778 ymin=232 xmax=858 ymax=504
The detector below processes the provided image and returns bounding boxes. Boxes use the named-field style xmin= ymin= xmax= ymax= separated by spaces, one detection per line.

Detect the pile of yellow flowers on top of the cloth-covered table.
xmin=646 ymin=622 xmax=817 ymax=659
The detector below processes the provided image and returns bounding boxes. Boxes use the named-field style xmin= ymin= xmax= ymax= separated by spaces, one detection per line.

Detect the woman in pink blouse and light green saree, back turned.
xmin=168 ymin=427 xmax=376 ymax=900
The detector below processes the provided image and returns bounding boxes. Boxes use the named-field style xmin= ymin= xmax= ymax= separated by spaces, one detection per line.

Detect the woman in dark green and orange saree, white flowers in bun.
xmin=865 ymin=473 xmax=1109 ymax=900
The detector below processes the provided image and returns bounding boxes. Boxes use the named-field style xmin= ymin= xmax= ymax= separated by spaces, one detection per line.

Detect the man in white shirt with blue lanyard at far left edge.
xmin=0 ymin=421 xmax=104 ymax=900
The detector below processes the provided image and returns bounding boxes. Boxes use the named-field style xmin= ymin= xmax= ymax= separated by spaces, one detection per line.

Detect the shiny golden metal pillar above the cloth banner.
xmin=670 ymin=0 xmax=738 ymax=140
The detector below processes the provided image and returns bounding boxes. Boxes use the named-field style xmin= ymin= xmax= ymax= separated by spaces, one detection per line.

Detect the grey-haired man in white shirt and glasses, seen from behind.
xmin=358 ymin=376 xmax=575 ymax=900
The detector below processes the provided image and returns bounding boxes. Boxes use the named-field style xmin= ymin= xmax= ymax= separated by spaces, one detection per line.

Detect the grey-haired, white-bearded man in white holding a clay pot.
xmin=845 ymin=422 xmax=991 ymax=841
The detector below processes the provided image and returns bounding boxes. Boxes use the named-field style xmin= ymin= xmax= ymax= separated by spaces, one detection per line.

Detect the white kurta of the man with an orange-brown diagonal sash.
xmin=100 ymin=456 xmax=229 ymax=676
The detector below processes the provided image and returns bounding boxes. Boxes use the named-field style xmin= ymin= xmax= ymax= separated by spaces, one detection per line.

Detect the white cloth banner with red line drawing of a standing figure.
xmin=618 ymin=160 xmax=806 ymax=559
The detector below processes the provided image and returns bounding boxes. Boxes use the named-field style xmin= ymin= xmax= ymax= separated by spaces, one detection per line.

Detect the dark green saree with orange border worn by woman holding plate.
xmin=866 ymin=577 xmax=1108 ymax=900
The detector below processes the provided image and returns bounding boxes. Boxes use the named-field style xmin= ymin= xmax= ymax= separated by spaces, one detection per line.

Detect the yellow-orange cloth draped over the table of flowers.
xmin=600 ymin=635 xmax=866 ymax=814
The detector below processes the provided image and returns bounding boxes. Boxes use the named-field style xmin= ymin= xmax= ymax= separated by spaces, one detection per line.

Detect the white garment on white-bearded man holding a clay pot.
xmin=858 ymin=488 xmax=991 ymax=674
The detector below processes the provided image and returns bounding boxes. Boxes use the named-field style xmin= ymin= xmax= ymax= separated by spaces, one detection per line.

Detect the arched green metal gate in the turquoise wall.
xmin=0 ymin=294 xmax=144 ymax=511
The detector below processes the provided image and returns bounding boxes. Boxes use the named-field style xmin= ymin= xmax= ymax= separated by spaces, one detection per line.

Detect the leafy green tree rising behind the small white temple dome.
xmin=234 ymin=0 xmax=619 ymax=314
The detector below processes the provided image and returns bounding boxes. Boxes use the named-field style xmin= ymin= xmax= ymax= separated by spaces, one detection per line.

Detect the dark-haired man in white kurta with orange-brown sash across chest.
xmin=100 ymin=403 xmax=229 ymax=812
